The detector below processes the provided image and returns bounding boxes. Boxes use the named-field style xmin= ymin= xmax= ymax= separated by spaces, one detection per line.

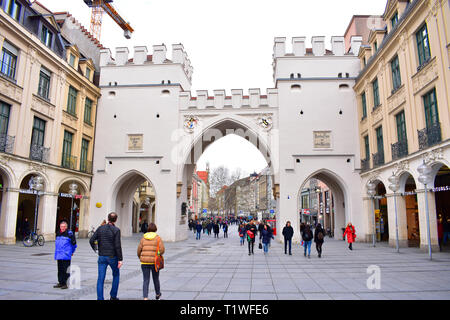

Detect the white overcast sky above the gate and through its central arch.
xmin=39 ymin=0 xmax=387 ymax=172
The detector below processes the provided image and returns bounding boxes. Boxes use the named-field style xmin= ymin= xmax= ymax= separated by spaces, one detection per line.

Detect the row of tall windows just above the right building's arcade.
xmin=363 ymin=88 xmax=439 ymax=162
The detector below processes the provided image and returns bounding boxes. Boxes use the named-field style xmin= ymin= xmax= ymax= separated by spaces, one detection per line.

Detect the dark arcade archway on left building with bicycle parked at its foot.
xmin=16 ymin=174 xmax=46 ymax=241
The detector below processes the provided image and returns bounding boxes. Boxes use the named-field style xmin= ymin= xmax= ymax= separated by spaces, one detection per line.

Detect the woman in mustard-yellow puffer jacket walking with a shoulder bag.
xmin=137 ymin=223 xmax=165 ymax=300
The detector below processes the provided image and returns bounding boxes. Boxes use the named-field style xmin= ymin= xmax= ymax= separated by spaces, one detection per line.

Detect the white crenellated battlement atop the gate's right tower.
xmin=273 ymin=36 xmax=362 ymax=59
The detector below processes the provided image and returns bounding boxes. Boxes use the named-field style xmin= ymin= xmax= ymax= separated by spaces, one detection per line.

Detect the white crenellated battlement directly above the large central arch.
xmin=179 ymin=88 xmax=278 ymax=110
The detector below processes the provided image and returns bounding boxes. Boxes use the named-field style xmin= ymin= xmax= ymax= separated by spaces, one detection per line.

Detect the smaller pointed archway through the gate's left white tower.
xmin=111 ymin=170 xmax=158 ymax=236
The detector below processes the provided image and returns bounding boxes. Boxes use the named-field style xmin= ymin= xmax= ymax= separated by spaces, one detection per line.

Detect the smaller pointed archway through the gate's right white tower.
xmin=297 ymin=169 xmax=352 ymax=239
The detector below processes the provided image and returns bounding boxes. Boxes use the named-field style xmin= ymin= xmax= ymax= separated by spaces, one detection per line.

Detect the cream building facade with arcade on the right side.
xmin=354 ymin=0 xmax=450 ymax=249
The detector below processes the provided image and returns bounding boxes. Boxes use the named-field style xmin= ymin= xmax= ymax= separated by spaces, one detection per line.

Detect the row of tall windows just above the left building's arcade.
xmin=0 ymin=101 xmax=89 ymax=172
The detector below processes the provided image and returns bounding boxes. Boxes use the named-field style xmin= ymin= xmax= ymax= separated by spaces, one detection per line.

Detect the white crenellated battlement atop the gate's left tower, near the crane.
xmin=100 ymin=43 xmax=193 ymax=80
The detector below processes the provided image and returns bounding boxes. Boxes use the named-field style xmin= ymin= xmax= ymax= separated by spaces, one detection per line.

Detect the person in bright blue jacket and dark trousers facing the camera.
xmin=53 ymin=219 xmax=77 ymax=289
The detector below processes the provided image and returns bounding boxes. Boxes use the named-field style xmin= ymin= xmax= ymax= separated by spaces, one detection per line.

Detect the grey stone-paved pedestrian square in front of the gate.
xmin=0 ymin=226 xmax=450 ymax=300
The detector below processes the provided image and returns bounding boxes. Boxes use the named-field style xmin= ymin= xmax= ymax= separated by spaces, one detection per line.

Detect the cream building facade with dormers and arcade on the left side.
xmin=0 ymin=0 xmax=100 ymax=244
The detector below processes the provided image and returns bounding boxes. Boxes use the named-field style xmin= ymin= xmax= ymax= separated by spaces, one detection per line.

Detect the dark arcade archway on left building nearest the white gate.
xmin=55 ymin=179 xmax=88 ymax=232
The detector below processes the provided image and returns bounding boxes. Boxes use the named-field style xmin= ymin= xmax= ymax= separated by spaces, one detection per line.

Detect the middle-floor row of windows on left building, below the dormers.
xmin=0 ymin=41 xmax=92 ymax=124
